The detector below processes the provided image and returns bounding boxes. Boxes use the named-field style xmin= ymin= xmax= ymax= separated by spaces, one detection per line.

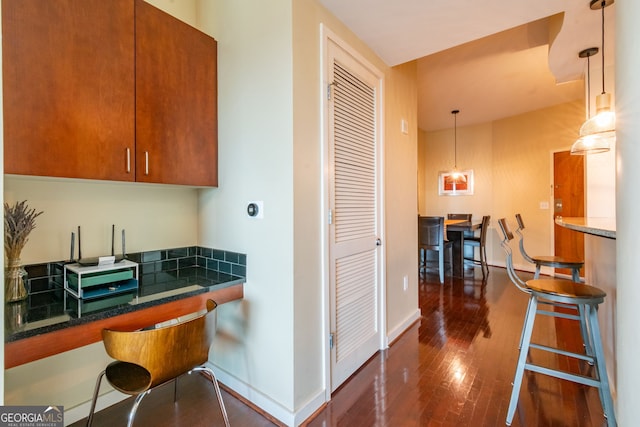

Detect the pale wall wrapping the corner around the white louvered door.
xmin=200 ymin=0 xmax=417 ymax=424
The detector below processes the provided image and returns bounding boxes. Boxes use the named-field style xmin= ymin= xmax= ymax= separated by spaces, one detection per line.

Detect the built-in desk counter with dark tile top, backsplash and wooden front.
xmin=5 ymin=247 xmax=246 ymax=369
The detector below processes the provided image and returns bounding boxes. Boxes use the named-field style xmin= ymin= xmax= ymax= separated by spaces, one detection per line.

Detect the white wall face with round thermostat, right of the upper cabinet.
xmin=199 ymin=1 xmax=298 ymax=419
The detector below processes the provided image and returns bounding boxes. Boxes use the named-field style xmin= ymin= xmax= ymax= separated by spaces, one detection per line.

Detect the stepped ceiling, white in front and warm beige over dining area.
xmin=320 ymin=0 xmax=615 ymax=131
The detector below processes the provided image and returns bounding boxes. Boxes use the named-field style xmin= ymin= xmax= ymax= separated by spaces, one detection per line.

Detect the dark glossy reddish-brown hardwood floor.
xmin=73 ymin=267 xmax=606 ymax=427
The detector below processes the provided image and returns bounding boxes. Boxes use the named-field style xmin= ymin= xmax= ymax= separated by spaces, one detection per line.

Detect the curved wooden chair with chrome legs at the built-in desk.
xmin=87 ymin=300 xmax=229 ymax=427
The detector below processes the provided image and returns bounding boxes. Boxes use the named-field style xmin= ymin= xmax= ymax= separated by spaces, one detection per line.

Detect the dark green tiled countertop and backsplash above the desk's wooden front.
xmin=5 ymin=247 xmax=245 ymax=343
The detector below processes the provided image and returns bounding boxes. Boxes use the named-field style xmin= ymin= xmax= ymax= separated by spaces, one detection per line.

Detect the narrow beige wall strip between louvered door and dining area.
xmin=383 ymin=62 xmax=420 ymax=341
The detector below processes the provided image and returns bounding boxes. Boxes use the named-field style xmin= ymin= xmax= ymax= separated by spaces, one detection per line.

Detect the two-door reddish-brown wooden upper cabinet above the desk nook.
xmin=2 ymin=0 xmax=218 ymax=186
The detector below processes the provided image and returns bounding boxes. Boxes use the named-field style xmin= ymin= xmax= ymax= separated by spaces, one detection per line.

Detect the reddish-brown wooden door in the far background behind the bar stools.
xmin=553 ymin=151 xmax=584 ymax=276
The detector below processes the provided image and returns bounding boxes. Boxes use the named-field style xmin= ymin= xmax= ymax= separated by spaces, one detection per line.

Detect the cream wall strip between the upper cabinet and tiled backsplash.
xmin=4 ymin=175 xmax=198 ymax=264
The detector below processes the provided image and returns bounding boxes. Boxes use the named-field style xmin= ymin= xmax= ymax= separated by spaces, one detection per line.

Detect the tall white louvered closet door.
xmin=329 ymin=40 xmax=380 ymax=391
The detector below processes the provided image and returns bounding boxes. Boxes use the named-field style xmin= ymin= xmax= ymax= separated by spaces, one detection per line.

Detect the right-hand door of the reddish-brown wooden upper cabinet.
xmin=136 ymin=0 xmax=218 ymax=186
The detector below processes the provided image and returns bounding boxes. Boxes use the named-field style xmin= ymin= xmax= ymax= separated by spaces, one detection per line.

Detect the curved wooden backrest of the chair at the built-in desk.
xmin=102 ymin=300 xmax=217 ymax=388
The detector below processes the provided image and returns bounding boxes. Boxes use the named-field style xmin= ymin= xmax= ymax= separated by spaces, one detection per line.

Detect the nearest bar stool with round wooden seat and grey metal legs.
xmin=498 ymin=218 xmax=616 ymax=426
